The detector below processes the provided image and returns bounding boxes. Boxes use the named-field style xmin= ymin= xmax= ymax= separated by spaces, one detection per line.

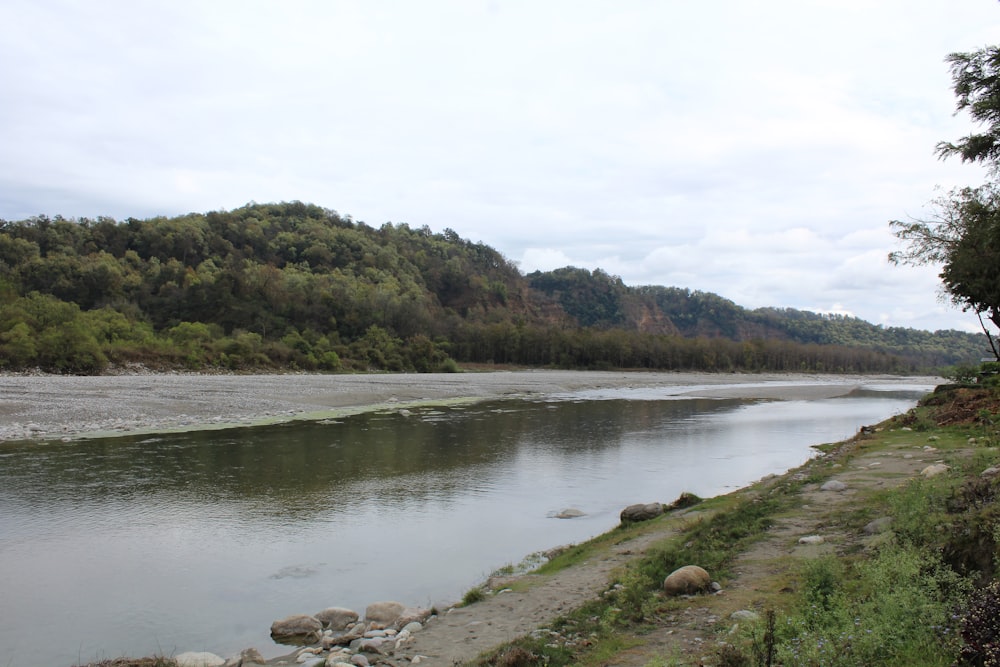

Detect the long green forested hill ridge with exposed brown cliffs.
xmin=0 ymin=202 xmax=986 ymax=373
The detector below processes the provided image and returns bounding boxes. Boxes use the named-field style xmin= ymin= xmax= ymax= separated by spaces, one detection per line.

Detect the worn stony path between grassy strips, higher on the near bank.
xmin=605 ymin=433 xmax=966 ymax=667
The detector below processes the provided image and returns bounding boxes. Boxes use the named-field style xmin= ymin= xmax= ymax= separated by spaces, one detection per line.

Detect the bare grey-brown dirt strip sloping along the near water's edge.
xmin=381 ymin=515 xmax=683 ymax=667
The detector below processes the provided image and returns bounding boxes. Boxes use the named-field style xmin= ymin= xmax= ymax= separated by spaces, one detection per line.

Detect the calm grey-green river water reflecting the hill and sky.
xmin=0 ymin=378 xmax=931 ymax=667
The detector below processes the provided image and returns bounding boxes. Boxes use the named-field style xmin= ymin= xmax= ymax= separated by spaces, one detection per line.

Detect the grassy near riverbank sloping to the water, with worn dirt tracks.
xmin=68 ymin=376 xmax=1000 ymax=667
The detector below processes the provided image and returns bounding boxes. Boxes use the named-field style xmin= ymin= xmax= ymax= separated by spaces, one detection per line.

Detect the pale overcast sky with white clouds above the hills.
xmin=0 ymin=0 xmax=1000 ymax=331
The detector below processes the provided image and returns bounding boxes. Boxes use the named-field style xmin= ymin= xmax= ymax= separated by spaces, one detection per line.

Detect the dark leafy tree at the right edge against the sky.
xmin=889 ymin=46 xmax=1000 ymax=360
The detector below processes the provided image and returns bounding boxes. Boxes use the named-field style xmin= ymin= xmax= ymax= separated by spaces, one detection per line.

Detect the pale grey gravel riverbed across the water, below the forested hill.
xmin=0 ymin=370 xmax=939 ymax=441
